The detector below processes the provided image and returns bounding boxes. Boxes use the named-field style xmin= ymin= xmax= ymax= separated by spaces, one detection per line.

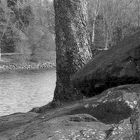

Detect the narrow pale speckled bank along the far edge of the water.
xmin=0 ymin=61 xmax=56 ymax=73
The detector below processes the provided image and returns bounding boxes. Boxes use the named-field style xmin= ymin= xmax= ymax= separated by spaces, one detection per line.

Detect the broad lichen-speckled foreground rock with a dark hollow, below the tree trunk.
xmin=0 ymin=84 xmax=140 ymax=140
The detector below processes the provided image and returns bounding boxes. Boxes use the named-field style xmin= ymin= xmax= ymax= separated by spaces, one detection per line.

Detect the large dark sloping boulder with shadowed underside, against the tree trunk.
xmin=72 ymin=32 xmax=140 ymax=96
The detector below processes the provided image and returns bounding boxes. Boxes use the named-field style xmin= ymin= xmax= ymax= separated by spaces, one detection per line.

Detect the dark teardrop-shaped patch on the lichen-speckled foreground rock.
xmin=65 ymin=101 xmax=132 ymax=124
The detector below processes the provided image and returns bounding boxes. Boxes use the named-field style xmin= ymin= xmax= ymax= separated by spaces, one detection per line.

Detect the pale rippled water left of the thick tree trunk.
xmin=0 ymin=70 xmax=56 ymax=116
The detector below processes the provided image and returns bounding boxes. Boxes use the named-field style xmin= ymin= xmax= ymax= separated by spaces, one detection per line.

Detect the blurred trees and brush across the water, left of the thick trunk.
xmin=0 ymin=0 xmax=55 ymax=59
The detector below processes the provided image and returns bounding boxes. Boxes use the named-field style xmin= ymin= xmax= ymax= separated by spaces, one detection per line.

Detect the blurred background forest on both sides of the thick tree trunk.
xmin=0 ymin=0 xmax=140 ymax=59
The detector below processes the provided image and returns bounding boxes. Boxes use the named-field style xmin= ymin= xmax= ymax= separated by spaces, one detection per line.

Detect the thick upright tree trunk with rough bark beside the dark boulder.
xmin=53 ymin=0 xmax=92 ymax=102
